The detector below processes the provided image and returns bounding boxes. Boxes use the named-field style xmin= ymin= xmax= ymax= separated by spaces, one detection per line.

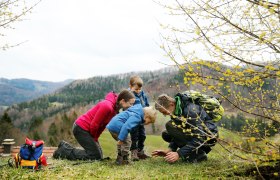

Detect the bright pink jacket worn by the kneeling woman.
xmin=75 ymin=92 xmax=117 ymax=141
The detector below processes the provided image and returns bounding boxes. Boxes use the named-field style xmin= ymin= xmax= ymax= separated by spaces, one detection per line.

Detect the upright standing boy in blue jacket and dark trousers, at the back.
xmin=129 ymin=76 xmax=149 ymax=161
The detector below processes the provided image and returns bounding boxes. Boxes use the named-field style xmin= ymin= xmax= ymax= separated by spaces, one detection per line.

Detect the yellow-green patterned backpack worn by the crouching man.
xmin=175 ymin=90 xmax=224 ymax=122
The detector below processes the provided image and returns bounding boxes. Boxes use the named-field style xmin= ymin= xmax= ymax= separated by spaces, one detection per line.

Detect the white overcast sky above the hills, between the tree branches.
xmin=0 ymin=0 xmax=172 ymax=82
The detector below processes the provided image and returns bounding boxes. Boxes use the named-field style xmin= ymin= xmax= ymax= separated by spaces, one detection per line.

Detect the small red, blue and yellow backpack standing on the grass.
xmin=14 ymin=138 xmax=47 ymax=170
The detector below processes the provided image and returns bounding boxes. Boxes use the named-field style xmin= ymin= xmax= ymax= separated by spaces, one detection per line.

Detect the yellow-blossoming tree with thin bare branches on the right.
xmin=159 ymin=0 xmax=280 ymax=171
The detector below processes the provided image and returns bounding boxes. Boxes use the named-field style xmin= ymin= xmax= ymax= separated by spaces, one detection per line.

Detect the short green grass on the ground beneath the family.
xmin=0 ymin=131 xmax=260 ymax=179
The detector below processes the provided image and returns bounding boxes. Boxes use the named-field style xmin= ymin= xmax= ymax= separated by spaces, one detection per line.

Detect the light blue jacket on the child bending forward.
xmin=106 ymin=104 xmax=144 ymax=141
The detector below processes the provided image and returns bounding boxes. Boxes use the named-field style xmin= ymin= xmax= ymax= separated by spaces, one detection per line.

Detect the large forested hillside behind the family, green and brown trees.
xmin=0 ymin=67 xmax=275 ymax=146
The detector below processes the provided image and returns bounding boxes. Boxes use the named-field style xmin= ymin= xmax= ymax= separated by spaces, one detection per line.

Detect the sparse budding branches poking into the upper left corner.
xmin=0 ymin=0 xmax=41 ymax=50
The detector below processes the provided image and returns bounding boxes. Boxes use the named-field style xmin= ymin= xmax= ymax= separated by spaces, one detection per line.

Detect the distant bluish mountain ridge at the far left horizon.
xmin=0 ymin=78 xmax=73 ymax=106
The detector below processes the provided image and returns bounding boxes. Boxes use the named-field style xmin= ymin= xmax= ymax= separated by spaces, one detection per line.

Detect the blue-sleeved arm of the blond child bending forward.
xmin=118 ymin=115 xmax=141 ymax=141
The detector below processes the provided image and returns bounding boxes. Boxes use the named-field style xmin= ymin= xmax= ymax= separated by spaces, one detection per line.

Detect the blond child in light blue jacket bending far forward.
xmin=106 ymin=104 xmax=156 ymax=165
